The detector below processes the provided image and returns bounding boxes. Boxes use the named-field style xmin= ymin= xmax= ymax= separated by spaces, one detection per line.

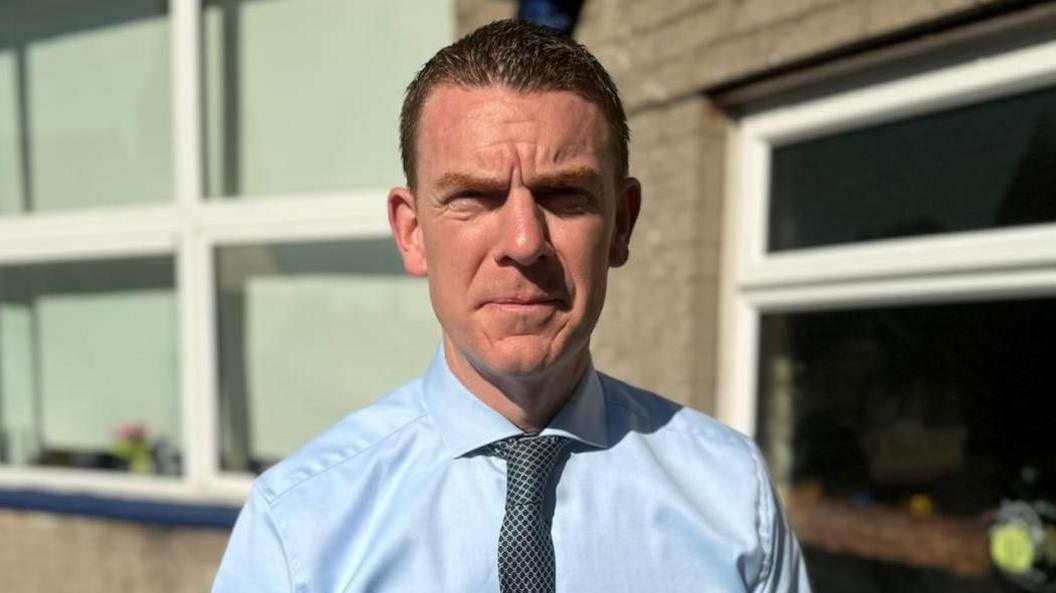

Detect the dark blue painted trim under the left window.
xmin=0 ymin=490 xmax=239 ymax=530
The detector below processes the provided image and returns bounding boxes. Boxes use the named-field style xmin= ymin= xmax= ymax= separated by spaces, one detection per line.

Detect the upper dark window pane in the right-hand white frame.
xmin=769 ymin=88 xmax=1056 ymax=251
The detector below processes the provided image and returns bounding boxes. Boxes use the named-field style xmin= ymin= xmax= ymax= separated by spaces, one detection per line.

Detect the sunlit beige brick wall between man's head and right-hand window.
xmin=592 ymin=95 xmax=725 ymax=409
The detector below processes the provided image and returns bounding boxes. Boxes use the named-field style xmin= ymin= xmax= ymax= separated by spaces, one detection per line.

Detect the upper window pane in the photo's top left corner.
xmin=0 ymin=0 xmax=172 ymax=215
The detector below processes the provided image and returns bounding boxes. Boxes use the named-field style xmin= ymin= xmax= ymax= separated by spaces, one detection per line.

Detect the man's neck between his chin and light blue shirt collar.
xmin=444 ymin=337 xmax=590 ymax=433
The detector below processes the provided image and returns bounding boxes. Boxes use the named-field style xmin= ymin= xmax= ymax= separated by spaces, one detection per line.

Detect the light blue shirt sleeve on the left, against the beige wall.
xmin=212 ymin=487 xmax=294 ymax=593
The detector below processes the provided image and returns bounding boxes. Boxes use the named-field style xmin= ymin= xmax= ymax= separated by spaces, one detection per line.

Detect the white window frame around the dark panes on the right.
xmin=717 ymin=35 xmax=1056 ymax=435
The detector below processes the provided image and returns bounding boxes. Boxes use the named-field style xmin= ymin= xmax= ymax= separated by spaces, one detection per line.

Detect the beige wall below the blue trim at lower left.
xmin=0 ymin=510 xmax=227 ymax=593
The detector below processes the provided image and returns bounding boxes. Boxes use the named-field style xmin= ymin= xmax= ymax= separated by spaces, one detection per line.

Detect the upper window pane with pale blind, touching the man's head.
xmin=204 ymin=0 xmax=454 ymax=196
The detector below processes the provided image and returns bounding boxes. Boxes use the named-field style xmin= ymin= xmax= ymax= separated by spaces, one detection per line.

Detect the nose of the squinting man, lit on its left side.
xmin=495 ymin=188 xmax=551 ymax=266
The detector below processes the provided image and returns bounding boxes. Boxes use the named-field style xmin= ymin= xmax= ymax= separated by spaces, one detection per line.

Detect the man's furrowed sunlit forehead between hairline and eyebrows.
xmin=417 ymin=85 xmax=611 ymax=178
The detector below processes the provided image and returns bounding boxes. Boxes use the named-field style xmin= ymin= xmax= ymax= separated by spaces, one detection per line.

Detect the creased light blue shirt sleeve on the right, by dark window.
xmin=752 ymin=443 xmax=811 ymax=593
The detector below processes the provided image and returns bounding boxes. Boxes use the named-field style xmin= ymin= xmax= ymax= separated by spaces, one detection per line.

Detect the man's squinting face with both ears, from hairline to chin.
xmin=390 ymin=85 xmax=640 ymax=376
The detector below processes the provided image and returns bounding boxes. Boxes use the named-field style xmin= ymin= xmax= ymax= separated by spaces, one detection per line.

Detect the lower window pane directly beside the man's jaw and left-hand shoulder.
xmin=218 ymin=240 xmax=439 ymax=472
